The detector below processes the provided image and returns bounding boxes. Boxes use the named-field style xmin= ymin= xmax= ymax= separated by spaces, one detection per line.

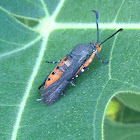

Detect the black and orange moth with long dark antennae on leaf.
xmin=37 ymin=10 xmax=122 ymax=105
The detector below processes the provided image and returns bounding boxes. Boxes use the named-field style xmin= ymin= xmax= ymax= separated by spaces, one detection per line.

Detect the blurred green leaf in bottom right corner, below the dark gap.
xmin=105 ymin=119 xmax=140 ymax=140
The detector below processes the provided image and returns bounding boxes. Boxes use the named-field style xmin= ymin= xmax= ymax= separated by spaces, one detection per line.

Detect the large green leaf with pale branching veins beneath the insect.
xmin=0 ymin=0 xmax=140 ymax=140
